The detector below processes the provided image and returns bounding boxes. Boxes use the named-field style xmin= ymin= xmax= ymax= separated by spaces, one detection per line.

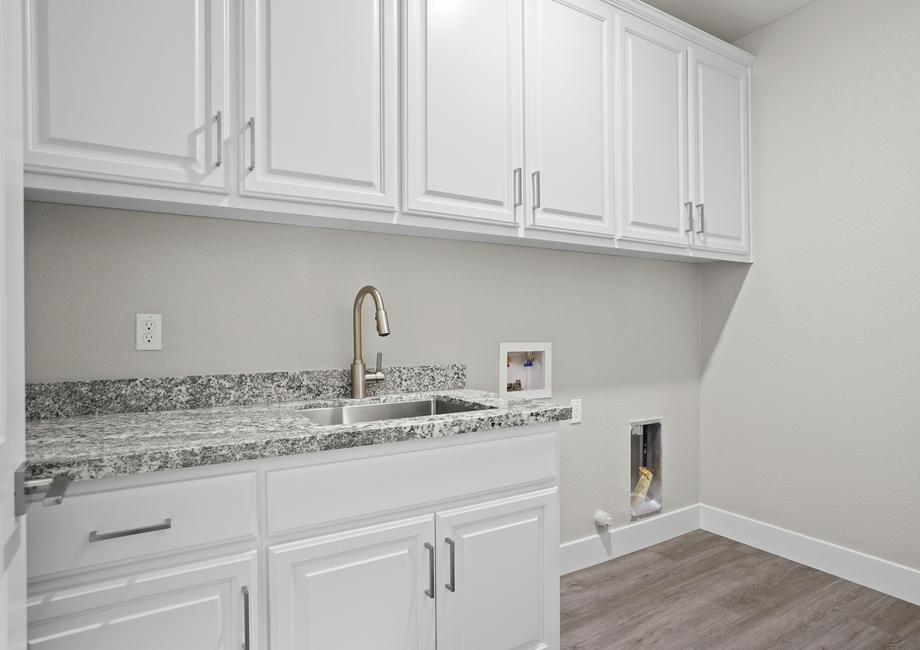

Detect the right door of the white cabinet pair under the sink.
xmin=435 ymin=488 xmax=559 ymax=650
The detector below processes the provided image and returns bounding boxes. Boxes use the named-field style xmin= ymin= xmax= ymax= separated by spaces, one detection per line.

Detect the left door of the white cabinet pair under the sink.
xmin=268 ymin=515 xmax=435 ymax=650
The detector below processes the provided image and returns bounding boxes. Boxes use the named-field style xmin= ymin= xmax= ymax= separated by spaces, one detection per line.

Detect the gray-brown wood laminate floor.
xmin=562 ymin=530 xmax=920 ymax=650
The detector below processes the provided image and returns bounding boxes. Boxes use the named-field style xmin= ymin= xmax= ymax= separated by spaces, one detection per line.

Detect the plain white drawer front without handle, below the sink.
xmin=265 ymin=430 xmax=559 ymax=536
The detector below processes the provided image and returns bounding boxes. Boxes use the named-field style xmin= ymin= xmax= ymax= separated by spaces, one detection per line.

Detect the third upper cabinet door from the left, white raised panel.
xmin=405 ymin=0 xmax=524 ymax=224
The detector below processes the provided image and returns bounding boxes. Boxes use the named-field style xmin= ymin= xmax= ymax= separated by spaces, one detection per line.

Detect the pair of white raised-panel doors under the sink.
xmin=268 ymin=487 xmax=559 ymax=650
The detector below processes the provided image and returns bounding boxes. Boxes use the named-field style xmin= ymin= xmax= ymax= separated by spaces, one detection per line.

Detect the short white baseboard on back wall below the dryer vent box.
xmin=559 ymin=505 xmax=700 ymax=575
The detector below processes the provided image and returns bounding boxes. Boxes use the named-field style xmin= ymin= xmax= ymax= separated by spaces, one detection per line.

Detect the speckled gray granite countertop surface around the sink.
xmin=26 ymin=390 xmax=572 ymax=480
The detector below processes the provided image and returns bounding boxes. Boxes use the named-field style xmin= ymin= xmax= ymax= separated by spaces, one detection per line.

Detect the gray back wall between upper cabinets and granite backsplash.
xmin=26 ymin=203 xmax=699 ymax=540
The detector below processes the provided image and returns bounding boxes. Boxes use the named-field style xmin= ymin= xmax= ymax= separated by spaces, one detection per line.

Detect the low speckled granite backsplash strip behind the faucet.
xmin=26 ymin=364 xmax=466 ymax=420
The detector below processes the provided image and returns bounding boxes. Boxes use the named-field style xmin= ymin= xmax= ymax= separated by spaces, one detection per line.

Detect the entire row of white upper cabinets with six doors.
xmin=21 ymin=0 xmax=753 ymax=261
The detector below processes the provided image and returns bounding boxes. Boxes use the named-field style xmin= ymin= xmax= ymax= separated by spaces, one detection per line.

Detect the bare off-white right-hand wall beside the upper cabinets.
xmin=701 ymin=0 xmax=920 ymax=568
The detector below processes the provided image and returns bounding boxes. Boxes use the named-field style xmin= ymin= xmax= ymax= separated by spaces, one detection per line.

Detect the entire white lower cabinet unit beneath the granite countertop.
xmin=27 ymin=424 xmax=559 ymax=650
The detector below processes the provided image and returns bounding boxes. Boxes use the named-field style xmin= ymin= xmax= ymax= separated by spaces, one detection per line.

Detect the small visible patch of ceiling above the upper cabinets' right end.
xmin=645 ymin=0 xmax=812 ymax=43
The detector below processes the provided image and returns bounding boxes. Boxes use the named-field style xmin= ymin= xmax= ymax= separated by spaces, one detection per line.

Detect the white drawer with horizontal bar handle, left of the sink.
xmin=28 ymin=473 xmax=258 ymax=578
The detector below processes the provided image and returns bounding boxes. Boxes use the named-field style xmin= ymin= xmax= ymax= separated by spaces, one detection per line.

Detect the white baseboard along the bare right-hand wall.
xmin=699 ymin=504 xmax=920 ymax=605
